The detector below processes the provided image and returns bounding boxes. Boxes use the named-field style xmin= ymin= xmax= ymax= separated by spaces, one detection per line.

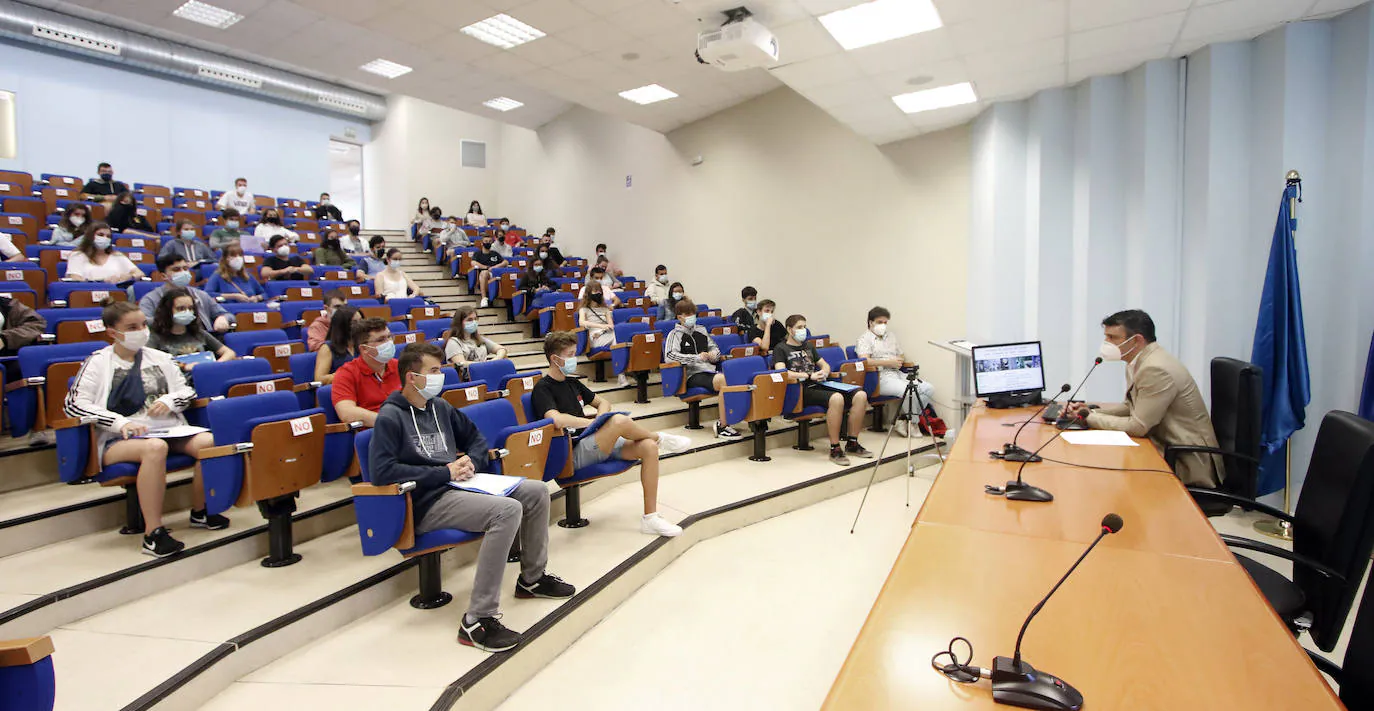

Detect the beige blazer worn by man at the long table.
xmin=1088 ymin=344 xmax=1226 ymax=488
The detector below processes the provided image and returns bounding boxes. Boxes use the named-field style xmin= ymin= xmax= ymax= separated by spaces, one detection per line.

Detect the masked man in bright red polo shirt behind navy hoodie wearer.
xmin=333 ymin=318 xmax=401 ymax=426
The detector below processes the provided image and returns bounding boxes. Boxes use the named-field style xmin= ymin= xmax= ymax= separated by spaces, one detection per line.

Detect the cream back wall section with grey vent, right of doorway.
xmin=363 ymin=95 xmax=514 ymax=230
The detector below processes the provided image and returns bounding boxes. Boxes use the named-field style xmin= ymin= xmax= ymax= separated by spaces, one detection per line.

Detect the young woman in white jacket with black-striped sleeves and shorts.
xmin=63 ymin=301 xmax=229 ymax=558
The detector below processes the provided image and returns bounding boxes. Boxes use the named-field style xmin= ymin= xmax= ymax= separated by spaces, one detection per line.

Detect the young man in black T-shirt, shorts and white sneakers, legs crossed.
xmin=530 ymin=331 xmax=691 ymax=536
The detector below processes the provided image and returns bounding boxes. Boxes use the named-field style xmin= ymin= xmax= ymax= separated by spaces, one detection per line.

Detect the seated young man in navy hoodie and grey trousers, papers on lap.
xmin=368 ymin=342 xmax=576 ymax=652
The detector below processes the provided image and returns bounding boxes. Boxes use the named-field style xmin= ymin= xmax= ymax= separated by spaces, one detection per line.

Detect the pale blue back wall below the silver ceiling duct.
xmin=0 ymin=43 xmax=371 ymax=199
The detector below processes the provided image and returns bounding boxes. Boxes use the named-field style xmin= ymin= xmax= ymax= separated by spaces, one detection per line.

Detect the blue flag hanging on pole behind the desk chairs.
xmin=1250 ymin=183 xmax=1312 ymax=495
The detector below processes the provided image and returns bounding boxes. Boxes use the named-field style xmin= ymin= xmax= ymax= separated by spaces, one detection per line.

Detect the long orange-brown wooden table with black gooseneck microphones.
xmin=824 ymin=404 xmax=1344 ymax=711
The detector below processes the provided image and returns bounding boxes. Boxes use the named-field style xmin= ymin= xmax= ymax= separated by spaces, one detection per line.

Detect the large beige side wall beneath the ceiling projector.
xmin=500 ymin=89 xmax=969 ymax=412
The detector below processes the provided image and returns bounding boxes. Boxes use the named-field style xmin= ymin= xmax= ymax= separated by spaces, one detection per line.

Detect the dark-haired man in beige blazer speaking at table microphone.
xmin=1073 ymin=311 xmax=1226 ymax=488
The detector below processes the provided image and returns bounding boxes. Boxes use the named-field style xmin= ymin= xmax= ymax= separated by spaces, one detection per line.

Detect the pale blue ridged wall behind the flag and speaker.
xmin=969 ymin=6 xmax=1374 ymax=497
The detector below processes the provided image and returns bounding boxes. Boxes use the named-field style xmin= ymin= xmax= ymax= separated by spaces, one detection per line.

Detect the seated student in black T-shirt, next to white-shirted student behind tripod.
xmin=760 ymin=312 xmax=872 ymax=466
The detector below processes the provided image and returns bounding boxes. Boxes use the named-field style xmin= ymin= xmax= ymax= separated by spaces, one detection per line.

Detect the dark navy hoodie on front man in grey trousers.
xmin=368 ymin=391 xmax=486 ymax=523
